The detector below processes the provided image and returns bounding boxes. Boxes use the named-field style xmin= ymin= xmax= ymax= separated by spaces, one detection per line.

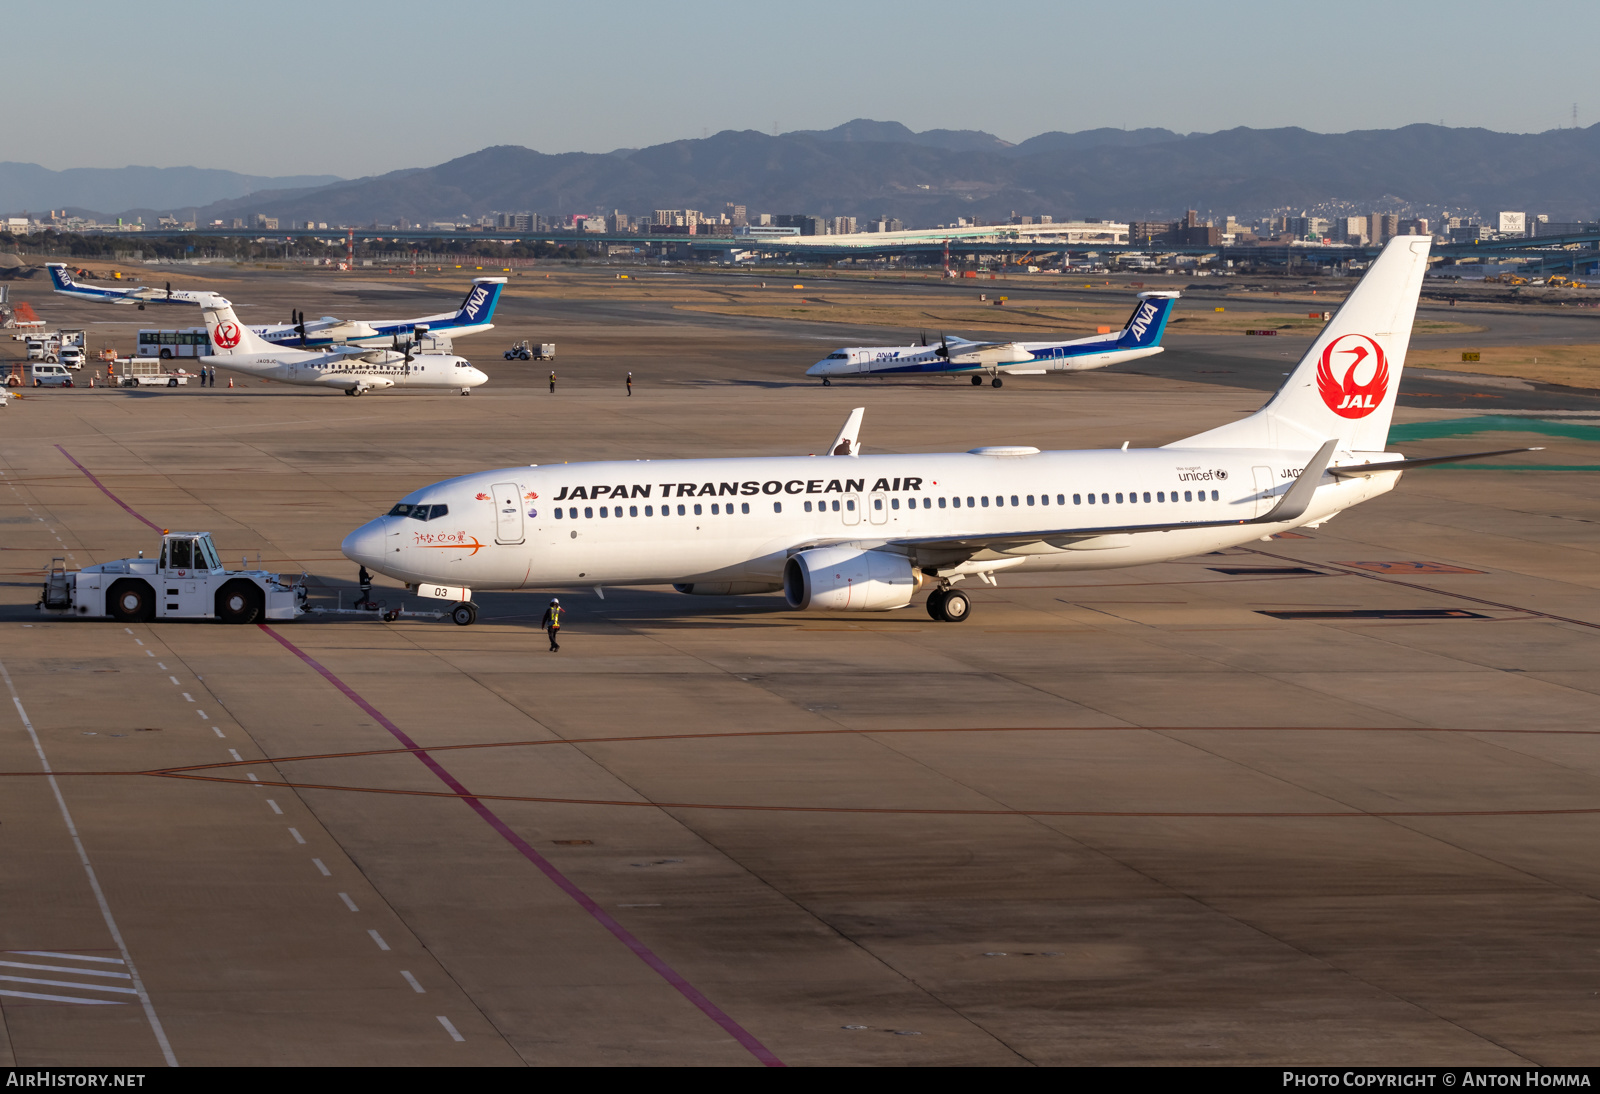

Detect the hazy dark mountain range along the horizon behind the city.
xmin=12 ymin=118 xmax=1600 ymax=224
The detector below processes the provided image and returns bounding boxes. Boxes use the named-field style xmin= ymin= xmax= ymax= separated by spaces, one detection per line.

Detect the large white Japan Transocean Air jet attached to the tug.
xmin=342 ymin=237 xmax=1525 ymax=624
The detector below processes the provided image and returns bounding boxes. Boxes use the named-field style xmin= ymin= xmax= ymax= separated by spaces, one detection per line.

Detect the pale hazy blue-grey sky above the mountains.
xmin=15 ymin=0 xmax=1600 ymax=178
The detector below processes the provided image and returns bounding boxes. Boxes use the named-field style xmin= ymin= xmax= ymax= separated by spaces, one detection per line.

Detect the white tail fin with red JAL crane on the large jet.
xmin=1168 ymin=235 xmax=1432 ymax=453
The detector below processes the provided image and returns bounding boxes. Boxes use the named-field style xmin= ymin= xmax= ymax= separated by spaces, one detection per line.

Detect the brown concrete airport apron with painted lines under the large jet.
xmin=0 ymin=260 xmax=1600 ymax=1067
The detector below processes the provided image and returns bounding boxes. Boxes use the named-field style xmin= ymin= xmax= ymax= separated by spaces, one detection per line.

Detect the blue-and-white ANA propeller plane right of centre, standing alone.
xmin=805 ymin=293 xmax=1178 ymax=387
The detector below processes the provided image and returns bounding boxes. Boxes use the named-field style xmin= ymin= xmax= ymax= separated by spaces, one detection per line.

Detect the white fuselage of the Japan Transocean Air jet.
xmin=342 ymin=448 xmax=1398 ymax=589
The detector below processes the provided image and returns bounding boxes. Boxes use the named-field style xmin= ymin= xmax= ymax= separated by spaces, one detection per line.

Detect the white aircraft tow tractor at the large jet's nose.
xmin=38 ymin=531 xmax=306 ymax=624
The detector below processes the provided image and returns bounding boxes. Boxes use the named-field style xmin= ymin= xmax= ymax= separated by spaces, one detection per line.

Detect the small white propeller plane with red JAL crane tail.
xmin=198 ymin=293 xmax=488 ymax=395
